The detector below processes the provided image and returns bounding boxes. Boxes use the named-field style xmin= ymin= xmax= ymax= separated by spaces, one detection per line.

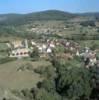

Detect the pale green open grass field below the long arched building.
xmin=0 ymin=59 xmax=50 ymax=95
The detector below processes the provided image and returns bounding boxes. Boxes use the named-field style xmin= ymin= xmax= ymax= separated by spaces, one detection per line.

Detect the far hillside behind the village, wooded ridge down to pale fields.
xmin=0 ymin=10 xmax=99 ymax=37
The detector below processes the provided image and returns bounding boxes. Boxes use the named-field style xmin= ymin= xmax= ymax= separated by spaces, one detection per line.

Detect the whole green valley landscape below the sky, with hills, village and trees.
xmin=0 ymin=10 xmax=99 ymax=100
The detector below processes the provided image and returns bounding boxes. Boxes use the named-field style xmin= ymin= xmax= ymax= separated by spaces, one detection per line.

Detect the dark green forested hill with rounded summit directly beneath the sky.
xmin=0 ymin=10 xmax=77 ymax=25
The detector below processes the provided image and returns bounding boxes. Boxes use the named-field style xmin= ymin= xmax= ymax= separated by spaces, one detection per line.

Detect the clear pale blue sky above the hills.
xmin=0 ymin=0 xmax=99 ymax=14
